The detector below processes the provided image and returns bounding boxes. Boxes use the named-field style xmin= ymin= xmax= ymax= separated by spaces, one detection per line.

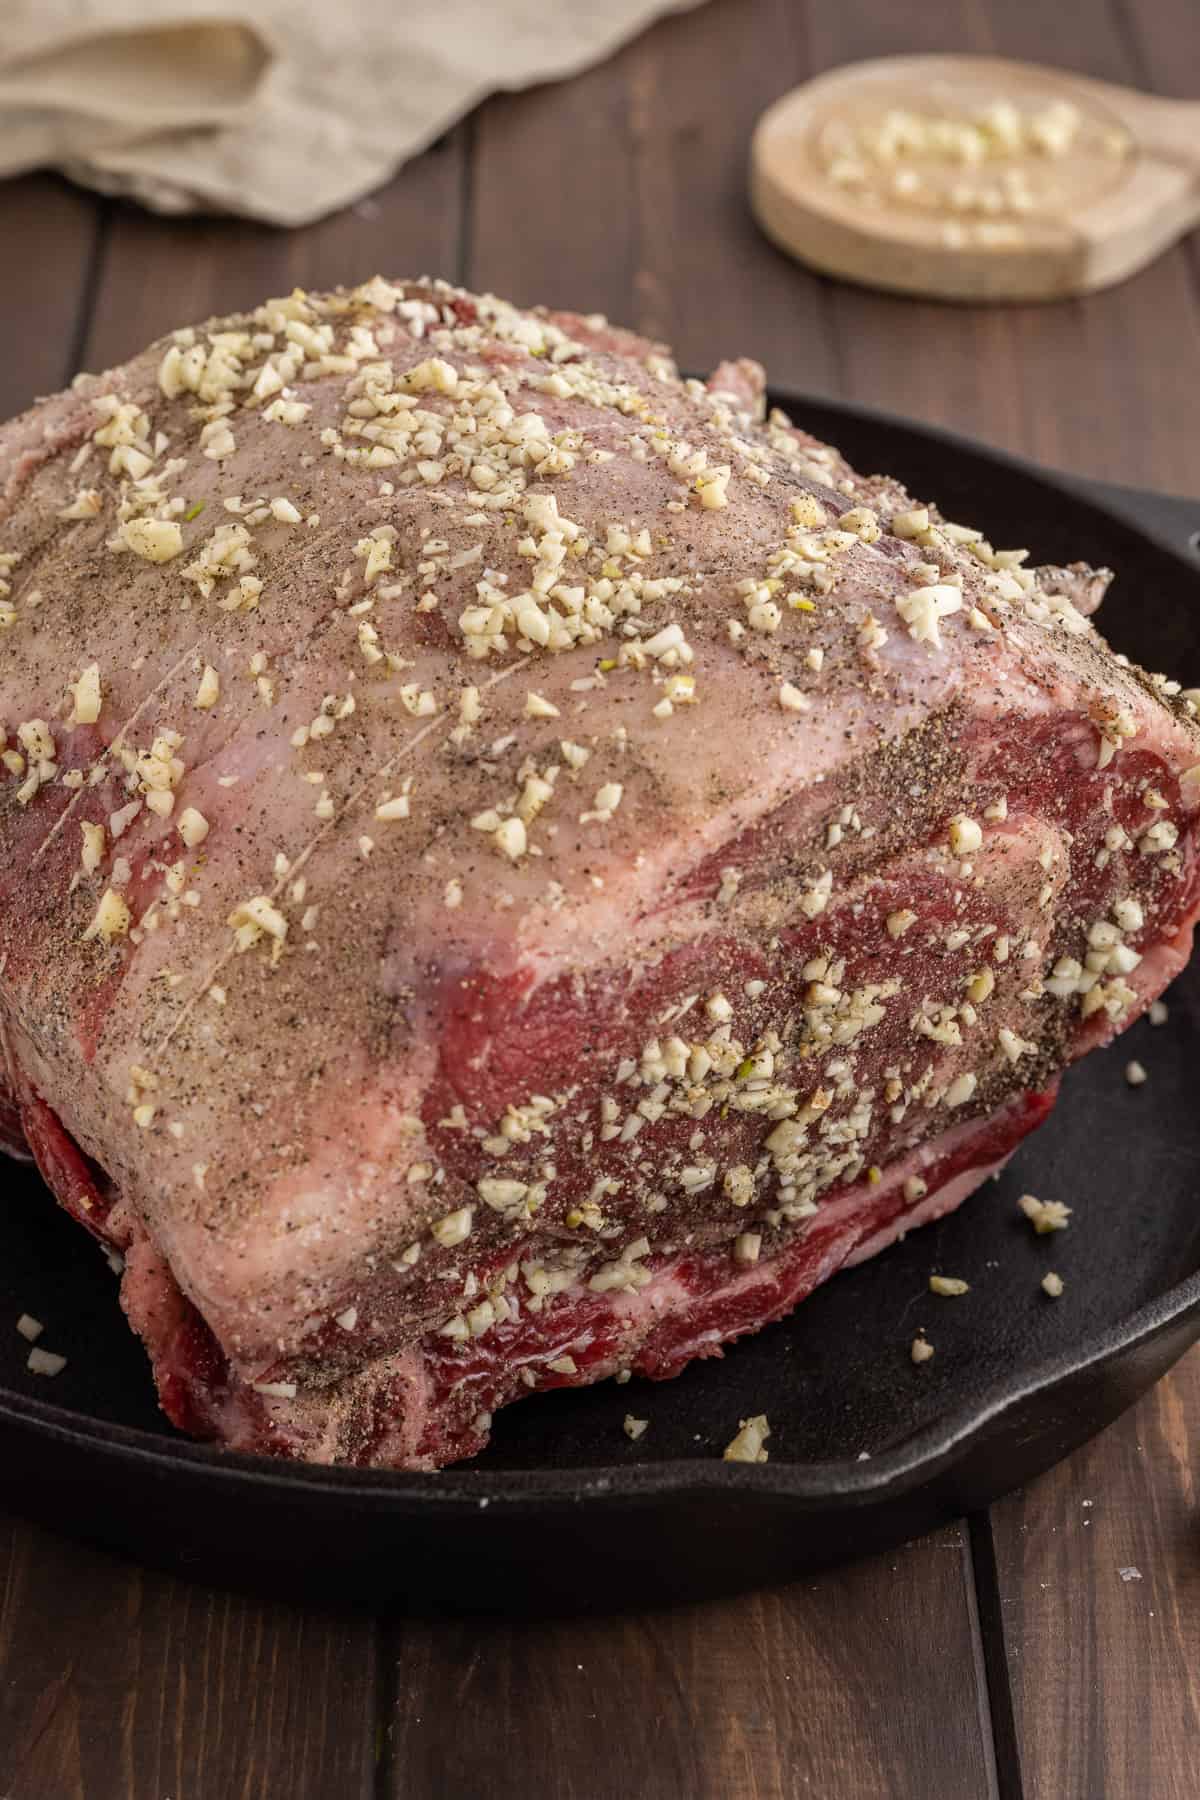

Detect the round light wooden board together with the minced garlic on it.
xmin=750 ymin=56 xmax=1200 ymax=301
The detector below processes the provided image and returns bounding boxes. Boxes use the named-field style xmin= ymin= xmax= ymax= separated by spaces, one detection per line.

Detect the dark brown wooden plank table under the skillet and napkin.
xmin=0 ymin=0 xmax=1200 ymax=1800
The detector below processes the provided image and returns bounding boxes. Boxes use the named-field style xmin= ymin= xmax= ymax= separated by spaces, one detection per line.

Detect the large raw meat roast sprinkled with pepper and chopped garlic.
xmin=0 ymin=279 xmax=1200 ymax=1469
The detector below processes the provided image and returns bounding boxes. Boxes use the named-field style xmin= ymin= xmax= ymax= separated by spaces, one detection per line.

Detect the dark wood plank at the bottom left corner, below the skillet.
xmin=0 ymin=1519 xmax=376 ymax=1800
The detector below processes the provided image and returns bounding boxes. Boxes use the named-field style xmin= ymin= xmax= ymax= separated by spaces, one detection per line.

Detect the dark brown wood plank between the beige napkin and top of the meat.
xmin=83 ymin=131 xmax=464 ymax=379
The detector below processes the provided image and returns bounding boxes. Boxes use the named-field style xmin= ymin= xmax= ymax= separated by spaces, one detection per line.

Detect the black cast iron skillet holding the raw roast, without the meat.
xmin=0 ymin=396 xmax=1200 ymax=1609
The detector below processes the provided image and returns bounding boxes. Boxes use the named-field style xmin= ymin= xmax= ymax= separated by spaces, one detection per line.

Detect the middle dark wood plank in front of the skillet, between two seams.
xmin=385 ymin=1528 xmax=995 ymax=1800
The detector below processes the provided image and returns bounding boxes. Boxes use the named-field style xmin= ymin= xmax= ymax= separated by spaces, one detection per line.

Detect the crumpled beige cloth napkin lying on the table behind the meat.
xmin=0 ymin=0 xmax=700 ymax=225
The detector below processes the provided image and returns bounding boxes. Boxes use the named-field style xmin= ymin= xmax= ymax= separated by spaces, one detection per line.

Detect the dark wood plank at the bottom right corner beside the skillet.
xmin=993 ymin=1350 xmax=1200 ymax=1800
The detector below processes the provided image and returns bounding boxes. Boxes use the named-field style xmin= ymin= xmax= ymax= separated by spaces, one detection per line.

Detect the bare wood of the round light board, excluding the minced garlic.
xmin=750 ymin=56 xmax=1200 ymax=302
